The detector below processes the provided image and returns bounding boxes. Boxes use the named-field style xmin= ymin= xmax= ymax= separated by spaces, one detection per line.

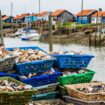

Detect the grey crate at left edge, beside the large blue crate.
xmin=0 ymin=56 xmax=16 ymax=72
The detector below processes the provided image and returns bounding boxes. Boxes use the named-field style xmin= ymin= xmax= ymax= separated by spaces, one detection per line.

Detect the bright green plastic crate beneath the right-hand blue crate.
xmin=58 ymin=69 xmax=95 ymax=86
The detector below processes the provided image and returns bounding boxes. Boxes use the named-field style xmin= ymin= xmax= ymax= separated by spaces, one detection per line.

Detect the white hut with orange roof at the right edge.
xmin=91 ymin=11 xmax=105 ymax=24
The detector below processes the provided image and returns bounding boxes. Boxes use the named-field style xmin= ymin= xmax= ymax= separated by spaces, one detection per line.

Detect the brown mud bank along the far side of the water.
xmin=40 ymin=32 xmax=105 ymax=46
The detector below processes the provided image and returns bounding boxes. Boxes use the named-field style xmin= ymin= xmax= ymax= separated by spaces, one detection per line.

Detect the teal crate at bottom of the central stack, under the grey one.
xmin=32 ymin=92 xmax=59 ymax=101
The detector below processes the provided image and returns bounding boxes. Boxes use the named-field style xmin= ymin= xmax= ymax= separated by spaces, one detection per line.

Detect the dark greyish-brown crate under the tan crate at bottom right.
xmin=63 ymin=96 xmax=105 ymax=105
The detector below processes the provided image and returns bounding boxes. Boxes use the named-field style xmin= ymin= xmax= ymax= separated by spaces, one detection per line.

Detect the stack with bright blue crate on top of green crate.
xmin=50 ymin=54 xmax=95 ymax=95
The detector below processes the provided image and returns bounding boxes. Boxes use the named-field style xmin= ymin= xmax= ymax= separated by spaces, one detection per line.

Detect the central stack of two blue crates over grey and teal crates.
xmin=7 ymin=47 xmax=61 ymax=101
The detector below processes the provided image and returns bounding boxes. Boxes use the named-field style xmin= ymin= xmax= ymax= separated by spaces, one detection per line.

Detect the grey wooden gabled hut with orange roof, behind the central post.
xmin=51 ymin=9 xmax=74 ymax=23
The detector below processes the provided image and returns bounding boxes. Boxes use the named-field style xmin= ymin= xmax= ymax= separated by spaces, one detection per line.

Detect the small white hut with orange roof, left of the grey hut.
xmin=37 ymin=11 xmax=50 ymax=21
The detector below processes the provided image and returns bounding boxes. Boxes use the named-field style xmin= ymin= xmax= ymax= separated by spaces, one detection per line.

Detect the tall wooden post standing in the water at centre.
xmin=49 ymin=13 xmax=53 ymax=51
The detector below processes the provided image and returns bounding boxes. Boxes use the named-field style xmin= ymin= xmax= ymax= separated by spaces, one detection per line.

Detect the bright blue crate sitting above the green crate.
xmin=53 ymin=54 xmax=94 ymax=69
